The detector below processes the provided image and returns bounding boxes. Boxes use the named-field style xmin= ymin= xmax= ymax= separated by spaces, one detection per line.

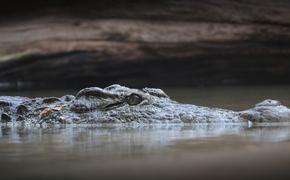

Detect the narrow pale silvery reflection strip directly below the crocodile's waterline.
xmin=0 ymin=123 xmax=290 ymax=144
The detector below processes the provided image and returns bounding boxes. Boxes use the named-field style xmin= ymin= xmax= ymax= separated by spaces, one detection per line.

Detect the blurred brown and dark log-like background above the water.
xmin=0 ymin=0 xmax=290 ymax=87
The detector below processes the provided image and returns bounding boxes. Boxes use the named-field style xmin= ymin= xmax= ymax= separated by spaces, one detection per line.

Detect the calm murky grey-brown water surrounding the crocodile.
xmin=0 ymin=86 xmax=290 ymax=179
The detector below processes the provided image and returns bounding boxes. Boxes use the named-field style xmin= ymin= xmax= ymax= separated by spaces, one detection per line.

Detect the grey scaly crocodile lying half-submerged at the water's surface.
xmin=0 ymin=84 xmax=290 ymax=125
